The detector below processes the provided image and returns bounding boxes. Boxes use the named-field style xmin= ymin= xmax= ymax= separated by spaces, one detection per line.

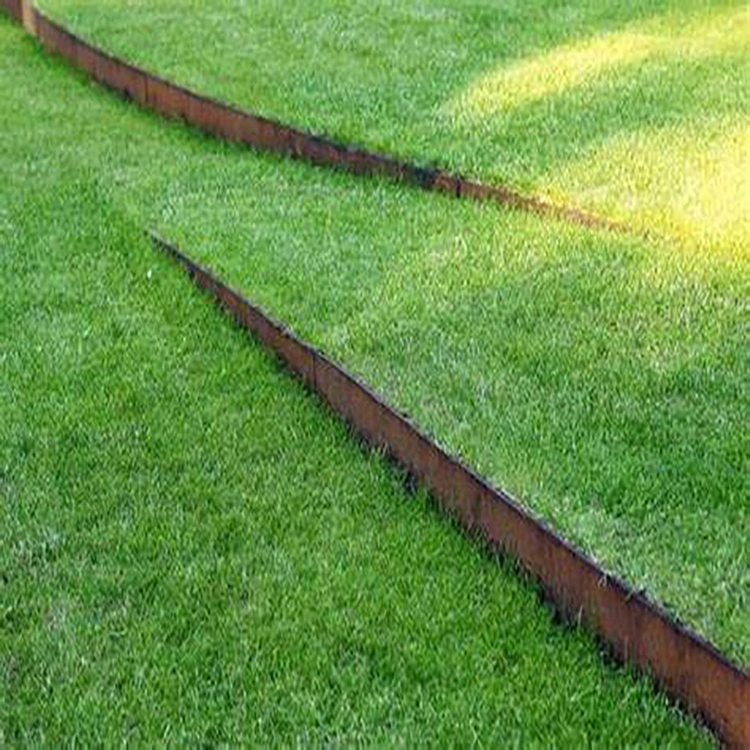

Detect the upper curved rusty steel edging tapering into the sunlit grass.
xmin=0 ymin=0 xmax=635 ymax=233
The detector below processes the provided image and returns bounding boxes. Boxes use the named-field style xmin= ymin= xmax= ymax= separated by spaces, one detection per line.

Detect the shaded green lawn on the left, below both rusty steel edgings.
xmin=0 ymin=18 xmax=710 ymax=746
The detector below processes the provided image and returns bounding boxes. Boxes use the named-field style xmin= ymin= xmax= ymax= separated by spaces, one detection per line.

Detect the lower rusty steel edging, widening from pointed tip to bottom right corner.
xmin=149 ymin=232 xmax=750 ymax=746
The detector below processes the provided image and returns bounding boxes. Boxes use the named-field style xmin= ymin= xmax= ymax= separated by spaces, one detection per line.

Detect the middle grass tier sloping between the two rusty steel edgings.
xmin=4 ymin=7 xmax=750 ymax=664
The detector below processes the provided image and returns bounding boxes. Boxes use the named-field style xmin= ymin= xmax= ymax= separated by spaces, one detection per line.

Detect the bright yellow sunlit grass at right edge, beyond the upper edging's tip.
xmin=549 ymin=118 xmax=750 ymax=256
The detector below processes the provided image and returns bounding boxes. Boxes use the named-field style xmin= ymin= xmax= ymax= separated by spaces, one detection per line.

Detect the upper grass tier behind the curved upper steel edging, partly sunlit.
xmin=42 ymin=0 xmax=750 ymax=253
